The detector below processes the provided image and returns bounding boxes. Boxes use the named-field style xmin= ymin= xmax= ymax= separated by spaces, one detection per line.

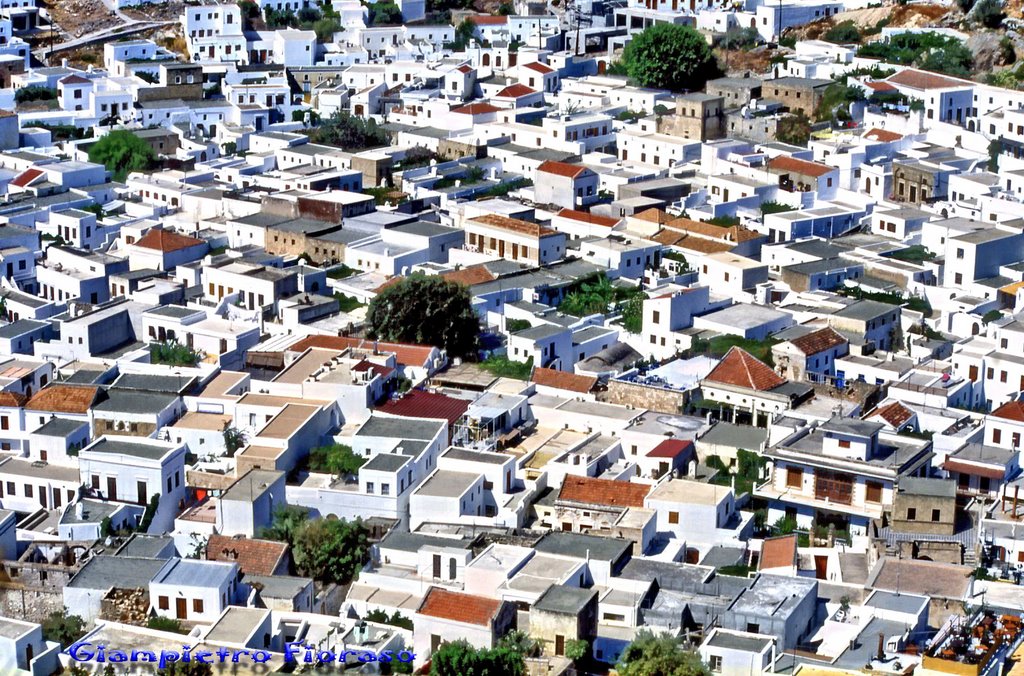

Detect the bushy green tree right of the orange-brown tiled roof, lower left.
xmin=292 ymin=519 xmax=370 ymax=585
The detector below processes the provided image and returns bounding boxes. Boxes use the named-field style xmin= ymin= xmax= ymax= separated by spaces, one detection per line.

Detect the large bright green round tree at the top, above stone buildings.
xmin=623 ymin=24 xmax=721 ymax=91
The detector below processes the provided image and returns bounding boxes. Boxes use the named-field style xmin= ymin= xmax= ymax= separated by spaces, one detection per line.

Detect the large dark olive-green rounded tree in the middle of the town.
xmin=367 ymin=274 xmax=480 ymax=357
